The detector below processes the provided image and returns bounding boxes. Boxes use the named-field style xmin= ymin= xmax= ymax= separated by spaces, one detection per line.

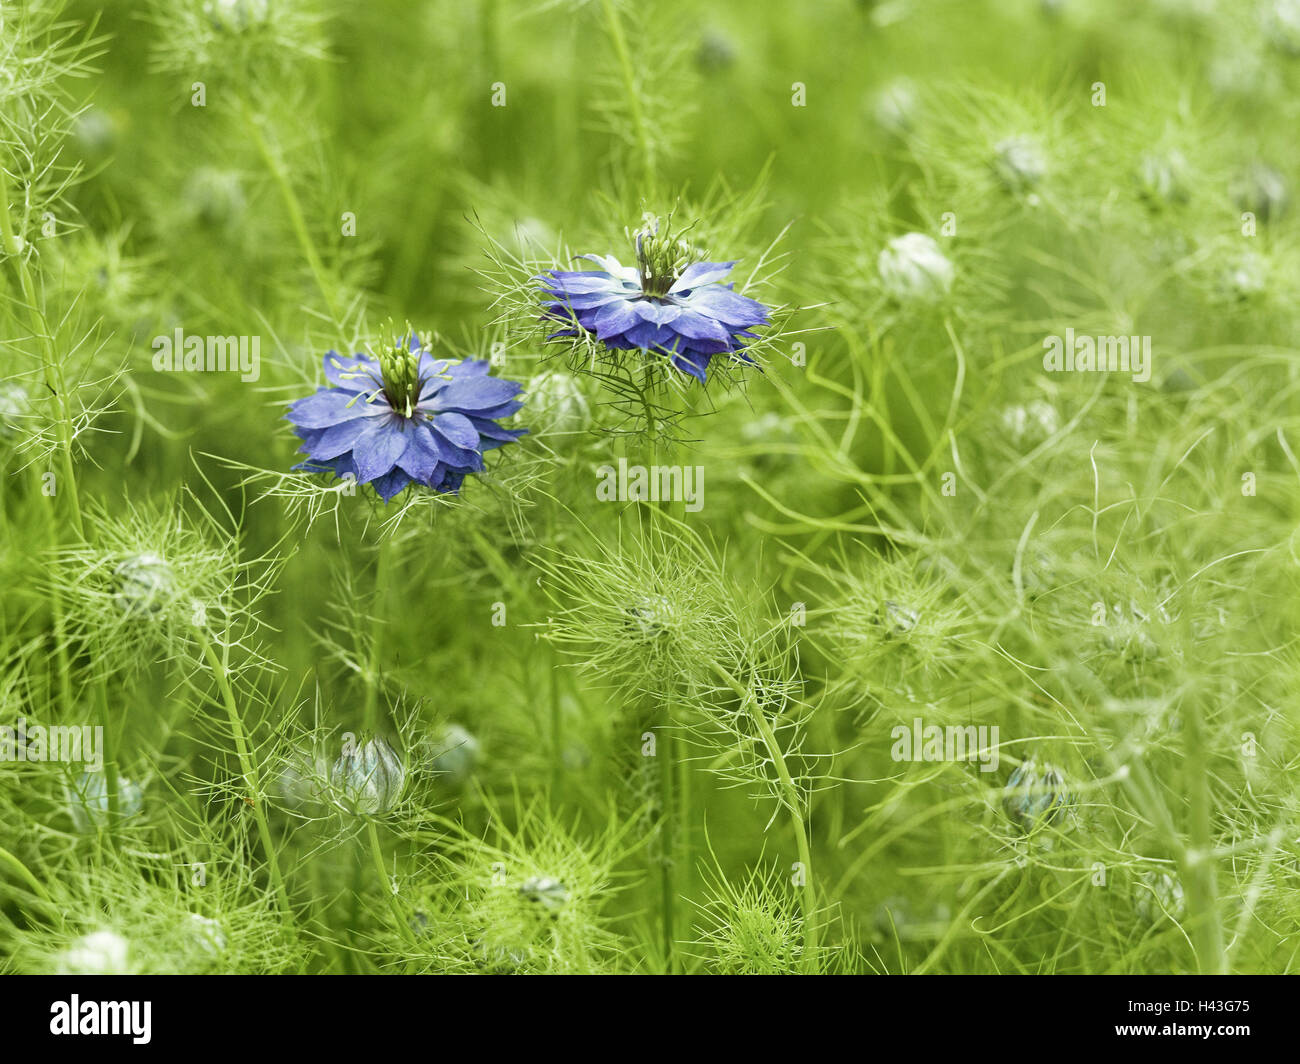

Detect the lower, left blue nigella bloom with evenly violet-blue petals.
xmin=285 ymin=333 xmax=527 ymax=502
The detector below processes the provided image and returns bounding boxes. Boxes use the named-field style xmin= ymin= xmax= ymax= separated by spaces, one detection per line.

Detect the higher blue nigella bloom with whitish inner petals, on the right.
xmin=533 ymin=219 xmax=771 ymax=384
